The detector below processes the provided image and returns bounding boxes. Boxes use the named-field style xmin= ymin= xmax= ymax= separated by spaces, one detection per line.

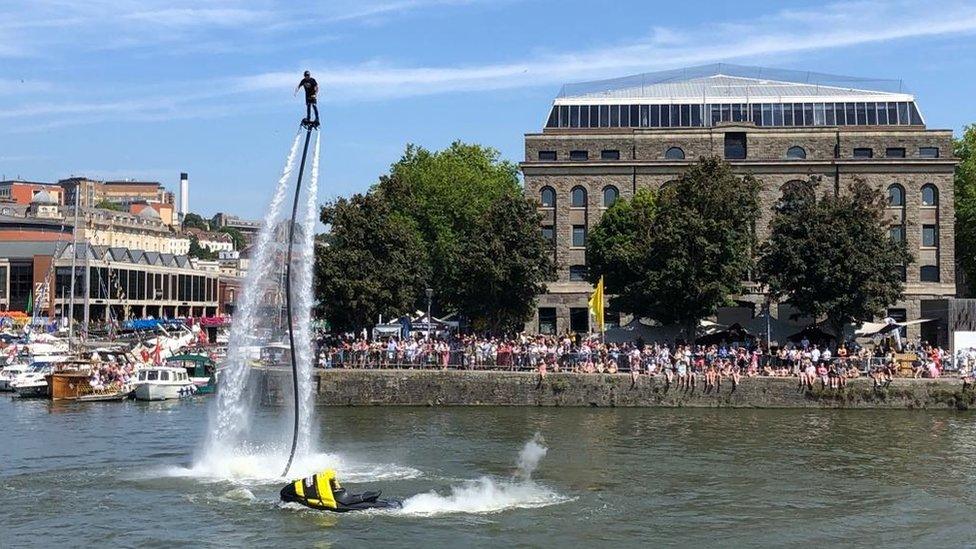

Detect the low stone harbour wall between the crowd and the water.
xmin=260 ymin=369 xmax=976 ymax=410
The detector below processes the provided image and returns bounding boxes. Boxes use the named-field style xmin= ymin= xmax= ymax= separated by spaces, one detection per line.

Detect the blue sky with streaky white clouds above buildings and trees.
xmin=0 ymin=0 xmax=976 ymax=218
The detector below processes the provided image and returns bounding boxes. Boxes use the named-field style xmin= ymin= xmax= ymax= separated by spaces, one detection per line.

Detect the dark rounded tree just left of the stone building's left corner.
xmin=454 ymin=193 xmax=554 ymax=333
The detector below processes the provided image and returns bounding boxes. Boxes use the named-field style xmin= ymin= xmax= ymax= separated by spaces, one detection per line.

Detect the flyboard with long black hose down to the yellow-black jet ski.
xmin=280 ymin=118 xmax=402 ymax=513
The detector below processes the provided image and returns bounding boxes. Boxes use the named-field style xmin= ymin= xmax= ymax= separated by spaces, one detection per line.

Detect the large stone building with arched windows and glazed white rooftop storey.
xmin=521 ymin=64 xmax=957 ymax=335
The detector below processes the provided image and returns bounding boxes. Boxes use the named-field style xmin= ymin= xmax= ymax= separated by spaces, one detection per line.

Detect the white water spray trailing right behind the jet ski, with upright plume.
xmin=394 ymin=433 xmax=570 ymax=516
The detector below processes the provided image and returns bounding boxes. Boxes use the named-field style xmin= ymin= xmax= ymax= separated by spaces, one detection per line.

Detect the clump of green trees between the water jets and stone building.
xmin=317 ymin=143 xmax=551 ymax=330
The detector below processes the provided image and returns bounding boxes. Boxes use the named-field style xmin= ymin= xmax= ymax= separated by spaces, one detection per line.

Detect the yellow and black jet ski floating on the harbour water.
xmin=281 ymin=469 xmax=403 ymax=513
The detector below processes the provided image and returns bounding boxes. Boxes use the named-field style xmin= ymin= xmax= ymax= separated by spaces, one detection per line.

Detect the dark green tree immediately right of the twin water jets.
xmin=315 ymin=192 xmax=430 ymax=331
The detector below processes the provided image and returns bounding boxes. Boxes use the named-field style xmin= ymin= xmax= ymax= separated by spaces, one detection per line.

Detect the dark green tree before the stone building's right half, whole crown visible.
xmin=758 ymin=178 xmax=912 ymax=336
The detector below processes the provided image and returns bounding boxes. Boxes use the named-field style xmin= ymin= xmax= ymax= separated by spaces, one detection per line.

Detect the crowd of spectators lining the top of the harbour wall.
xmin=318 ymin=334 xmax=952 ymax=390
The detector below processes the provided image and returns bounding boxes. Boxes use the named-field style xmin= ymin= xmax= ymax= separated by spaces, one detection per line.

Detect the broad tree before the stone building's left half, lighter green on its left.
xmin=588 ymin=158 xmax=759 ymax=339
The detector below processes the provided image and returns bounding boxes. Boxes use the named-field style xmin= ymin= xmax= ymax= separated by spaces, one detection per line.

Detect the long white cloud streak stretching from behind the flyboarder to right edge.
xmin=231 ymin=2 xmax=976 ymax=100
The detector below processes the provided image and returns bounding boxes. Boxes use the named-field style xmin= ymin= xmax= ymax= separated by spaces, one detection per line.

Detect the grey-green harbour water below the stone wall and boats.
xmin=0 ymin=396 xmax=976 ymax=547
